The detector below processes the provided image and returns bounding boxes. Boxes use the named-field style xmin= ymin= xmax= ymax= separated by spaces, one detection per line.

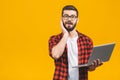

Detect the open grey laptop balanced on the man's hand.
xmin=73 ymin=43 xmax=115 ymax=68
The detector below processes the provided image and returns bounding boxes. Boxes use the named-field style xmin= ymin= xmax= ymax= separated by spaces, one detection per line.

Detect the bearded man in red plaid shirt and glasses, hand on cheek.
xmin=49 ymin=5 xmax=102 ymax=80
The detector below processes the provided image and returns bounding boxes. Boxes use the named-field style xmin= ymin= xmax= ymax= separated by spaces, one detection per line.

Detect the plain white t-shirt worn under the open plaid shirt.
xmin=67 ymin=36 xmax=79 ymax=80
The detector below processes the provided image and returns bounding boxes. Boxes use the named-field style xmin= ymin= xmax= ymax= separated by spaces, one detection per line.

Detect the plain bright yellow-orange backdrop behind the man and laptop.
xmin=0 ymin=0 xmax=120 ymax=80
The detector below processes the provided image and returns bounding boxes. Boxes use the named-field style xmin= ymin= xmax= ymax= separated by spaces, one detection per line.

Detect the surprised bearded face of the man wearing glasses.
xmin=62 ymin=10 xmax=78 ymax=32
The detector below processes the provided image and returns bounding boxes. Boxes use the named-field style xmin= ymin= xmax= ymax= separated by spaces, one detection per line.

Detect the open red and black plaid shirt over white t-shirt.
xmin=49 ymin=31 xmax=93 ymax=80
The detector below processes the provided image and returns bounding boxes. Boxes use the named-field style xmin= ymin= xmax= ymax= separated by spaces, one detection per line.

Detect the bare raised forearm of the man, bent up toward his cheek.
xmin=52 ymin=34 xmax=68 ymax=59
